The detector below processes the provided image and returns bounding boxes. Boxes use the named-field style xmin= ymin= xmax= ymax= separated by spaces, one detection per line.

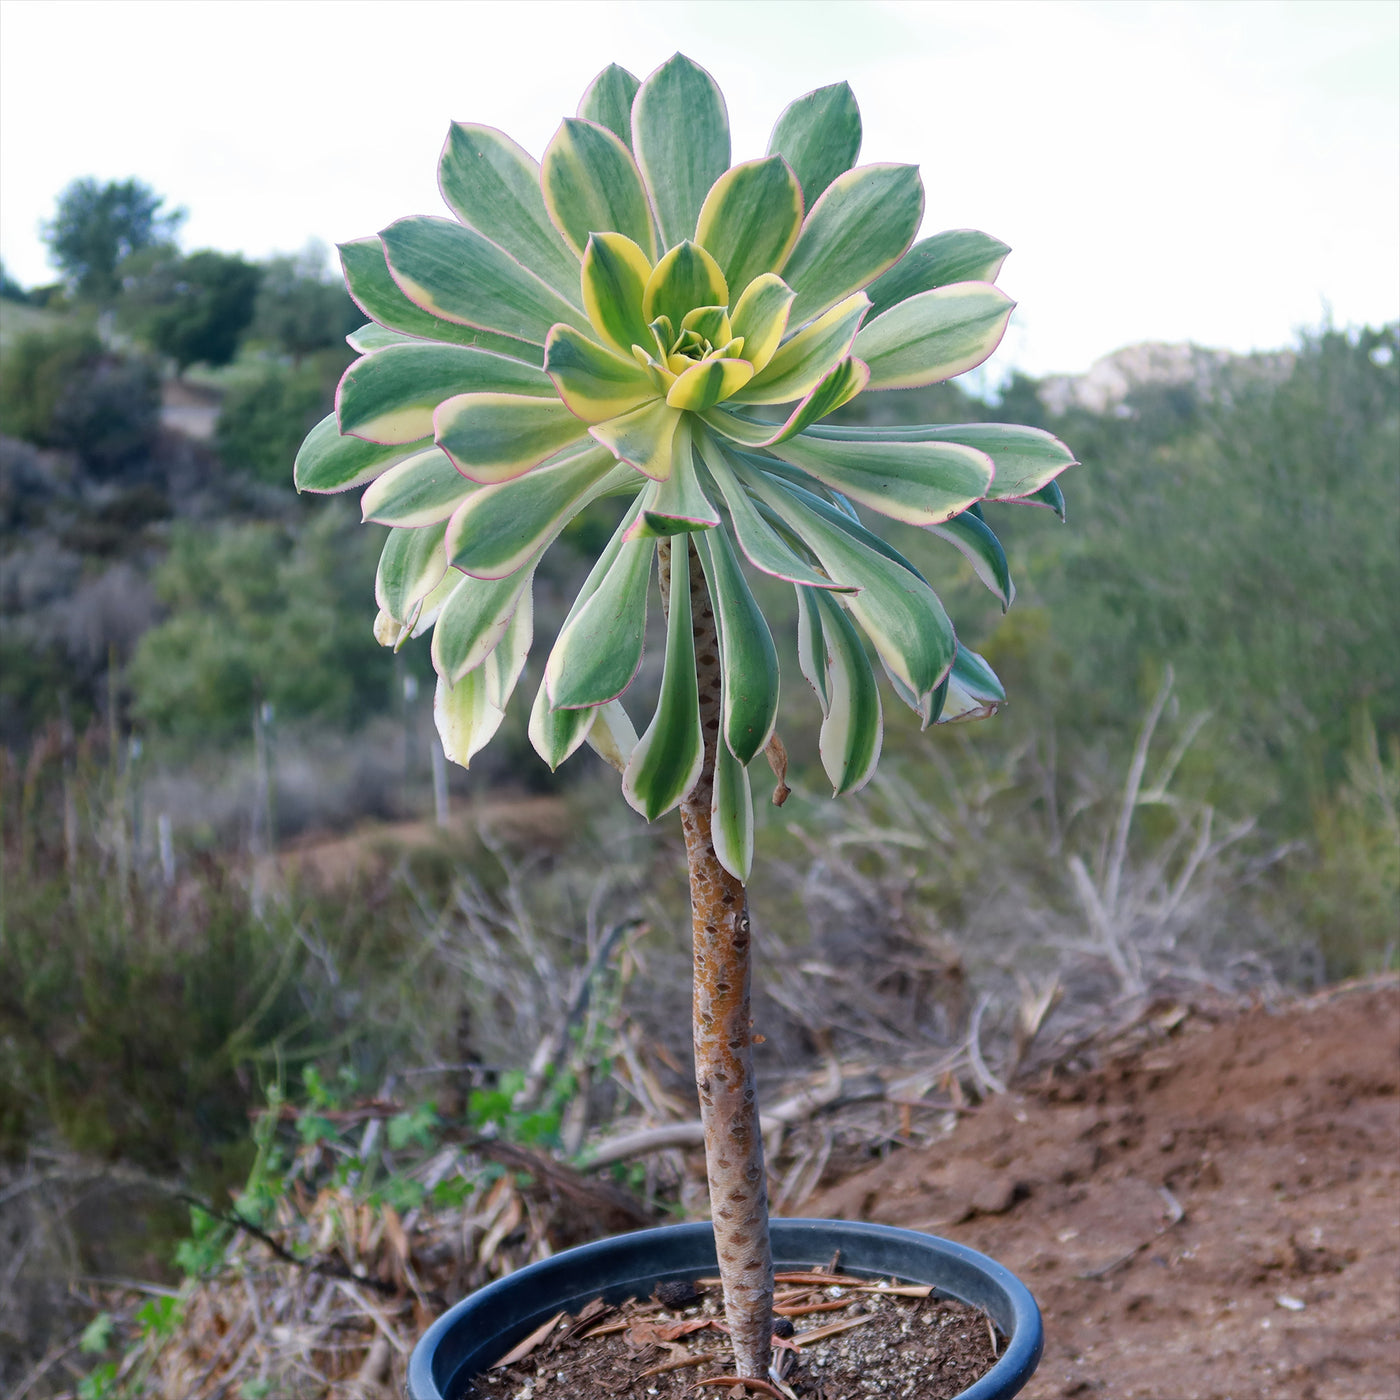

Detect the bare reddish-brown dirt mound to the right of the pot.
xmin=802 ymin=983 xmax=1400 ymax=1400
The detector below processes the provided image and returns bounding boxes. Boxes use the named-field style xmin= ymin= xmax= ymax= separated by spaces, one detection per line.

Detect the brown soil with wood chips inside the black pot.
xmin=462 ymin=1273 xmax=1004 ymax=1400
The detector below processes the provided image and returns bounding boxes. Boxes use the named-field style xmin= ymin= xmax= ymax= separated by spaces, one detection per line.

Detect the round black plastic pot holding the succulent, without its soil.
xmin=409 ymin=1219 xmax=1043 ymax=1400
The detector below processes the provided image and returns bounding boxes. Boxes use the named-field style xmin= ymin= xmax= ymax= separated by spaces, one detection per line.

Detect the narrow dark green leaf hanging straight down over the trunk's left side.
xmin=622 ymin=535 xmax=704 ymax=822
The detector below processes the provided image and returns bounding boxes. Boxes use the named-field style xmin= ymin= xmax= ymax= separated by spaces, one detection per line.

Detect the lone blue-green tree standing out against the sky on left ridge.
xmin=43 ymin=175 xmax=185 ymax=302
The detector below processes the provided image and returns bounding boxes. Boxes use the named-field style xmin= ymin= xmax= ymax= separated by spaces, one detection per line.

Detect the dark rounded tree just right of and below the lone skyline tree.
xmin=118 ymin=246 xmax=262 ymax=374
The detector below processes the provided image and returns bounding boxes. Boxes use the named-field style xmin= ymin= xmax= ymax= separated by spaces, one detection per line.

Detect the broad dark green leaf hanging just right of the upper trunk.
xmin=696 ymin=529 xmax=778 ymax=767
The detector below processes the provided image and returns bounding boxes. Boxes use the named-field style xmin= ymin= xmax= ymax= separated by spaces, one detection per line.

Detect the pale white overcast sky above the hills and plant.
xmin=0 ymin=0 xmax=1400 ymax=374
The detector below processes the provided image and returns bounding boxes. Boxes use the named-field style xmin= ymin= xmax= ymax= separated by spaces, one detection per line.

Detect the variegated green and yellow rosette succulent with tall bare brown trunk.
xmin=295 ymin=55 xmax=1072 ymax=1378
